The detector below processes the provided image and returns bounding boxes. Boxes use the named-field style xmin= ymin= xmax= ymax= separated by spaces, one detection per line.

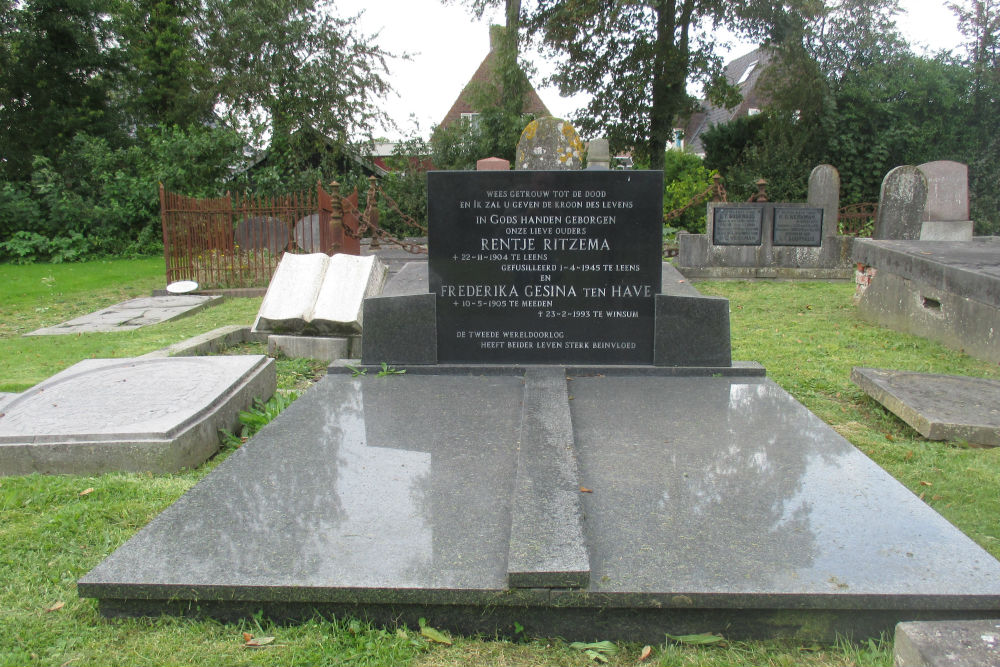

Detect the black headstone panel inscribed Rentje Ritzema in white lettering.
xmin=427 ymin=171 xmax=663 ymax=364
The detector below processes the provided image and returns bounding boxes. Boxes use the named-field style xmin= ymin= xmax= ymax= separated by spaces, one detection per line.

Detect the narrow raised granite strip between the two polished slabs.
xmin=507 ymin=368 xmax=590 ymax=588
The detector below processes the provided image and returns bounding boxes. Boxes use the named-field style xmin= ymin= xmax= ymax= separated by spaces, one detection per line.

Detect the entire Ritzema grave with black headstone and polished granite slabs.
xmin=78 ymin=160 xmax=1000 ymax=642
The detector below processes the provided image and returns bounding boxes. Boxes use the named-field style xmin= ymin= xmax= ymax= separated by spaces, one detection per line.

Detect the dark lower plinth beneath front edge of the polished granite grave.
xmin=92 ymin=595 xmax=988 ymax=644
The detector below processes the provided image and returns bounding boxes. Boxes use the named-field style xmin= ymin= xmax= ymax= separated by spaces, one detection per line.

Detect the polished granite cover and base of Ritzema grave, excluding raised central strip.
xmin=79 ymin=369 xmax=1000 ymax=642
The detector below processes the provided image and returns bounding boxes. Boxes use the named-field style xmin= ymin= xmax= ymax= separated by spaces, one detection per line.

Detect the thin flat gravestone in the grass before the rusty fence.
xmin=24 ymin=294 xmax=223 ymax=336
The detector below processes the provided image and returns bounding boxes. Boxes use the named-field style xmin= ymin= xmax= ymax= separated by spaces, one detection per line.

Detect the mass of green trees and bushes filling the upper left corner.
xmin=0 ymin=0 xmax=391 ymax=260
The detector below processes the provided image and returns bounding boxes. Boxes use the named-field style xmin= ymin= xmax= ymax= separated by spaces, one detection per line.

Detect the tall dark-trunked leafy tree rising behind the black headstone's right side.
xmin=525 ymin=0 xmax=780 ymax=169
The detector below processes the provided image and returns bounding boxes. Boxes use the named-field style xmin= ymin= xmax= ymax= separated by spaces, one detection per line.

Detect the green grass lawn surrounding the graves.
xmin=0 ymin=258 xmax=1000 ymax=665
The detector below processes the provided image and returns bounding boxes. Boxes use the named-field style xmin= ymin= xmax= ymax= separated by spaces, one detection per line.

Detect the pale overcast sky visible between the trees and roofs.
xmin=335 ymin=0 xmax=961 ymax=138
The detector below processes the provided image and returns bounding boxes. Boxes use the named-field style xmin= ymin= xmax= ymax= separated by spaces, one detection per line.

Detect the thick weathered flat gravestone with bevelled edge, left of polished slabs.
xmin=0 ymin=355 xmax=275 ymax=475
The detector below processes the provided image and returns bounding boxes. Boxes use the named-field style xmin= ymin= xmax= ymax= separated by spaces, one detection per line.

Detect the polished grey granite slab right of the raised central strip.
xmin=570 ymin=377 xmax=1000 ymax=608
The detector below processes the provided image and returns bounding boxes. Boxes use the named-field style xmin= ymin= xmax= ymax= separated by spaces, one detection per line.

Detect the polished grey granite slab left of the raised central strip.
xmin=80 ymin=376 xmax=522 ymax=601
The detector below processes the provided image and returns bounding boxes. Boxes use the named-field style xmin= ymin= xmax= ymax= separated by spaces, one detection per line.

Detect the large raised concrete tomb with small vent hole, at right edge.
xmin=852 ymin=236 xmax=1000 ymax=362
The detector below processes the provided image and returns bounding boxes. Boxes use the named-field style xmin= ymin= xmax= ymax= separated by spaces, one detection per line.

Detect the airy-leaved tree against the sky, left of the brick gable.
xmin=200 ymin=0 xmax=391 ymax=153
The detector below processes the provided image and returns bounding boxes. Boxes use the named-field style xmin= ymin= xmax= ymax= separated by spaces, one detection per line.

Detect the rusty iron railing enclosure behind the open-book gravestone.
xmin=160 ymin=183 xmax=361 ymax=289
